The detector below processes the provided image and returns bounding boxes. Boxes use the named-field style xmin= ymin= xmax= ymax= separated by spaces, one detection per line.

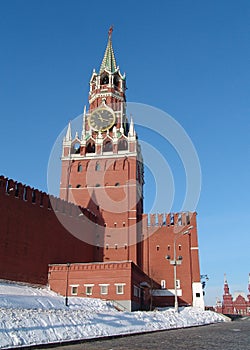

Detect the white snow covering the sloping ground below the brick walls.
xmin=0 ymin=282 xmax=225 ymax=349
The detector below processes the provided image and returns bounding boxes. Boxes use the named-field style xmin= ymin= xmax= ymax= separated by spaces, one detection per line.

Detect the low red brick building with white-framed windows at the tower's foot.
xmin=48 ymin=261 xmax=160 ymax=311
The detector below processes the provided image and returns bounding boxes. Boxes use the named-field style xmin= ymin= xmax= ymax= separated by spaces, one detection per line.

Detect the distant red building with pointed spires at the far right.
xmin=215 ymin=274 xmax=250 ymax=316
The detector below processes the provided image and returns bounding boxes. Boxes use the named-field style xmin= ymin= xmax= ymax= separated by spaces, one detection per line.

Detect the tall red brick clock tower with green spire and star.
xmin=60 ymin=28 xmax=143 ymax=266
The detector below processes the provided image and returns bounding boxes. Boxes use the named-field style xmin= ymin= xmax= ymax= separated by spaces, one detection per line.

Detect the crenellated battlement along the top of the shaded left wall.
xmin=0 ymin=175 xmax=97 ymax=222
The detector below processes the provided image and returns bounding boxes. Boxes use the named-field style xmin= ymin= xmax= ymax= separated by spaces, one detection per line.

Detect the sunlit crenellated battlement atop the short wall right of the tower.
xmin=143 ymin=212 xmax=196 ymax=227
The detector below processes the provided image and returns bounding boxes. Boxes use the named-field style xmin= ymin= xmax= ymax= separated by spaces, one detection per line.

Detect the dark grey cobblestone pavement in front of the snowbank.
xmin=51 ymin=318 xmax=250 ymax=350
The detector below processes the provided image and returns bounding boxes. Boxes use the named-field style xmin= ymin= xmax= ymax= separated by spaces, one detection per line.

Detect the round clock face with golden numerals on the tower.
xmin=88 ymin=108 xmax=115 ymax=131
